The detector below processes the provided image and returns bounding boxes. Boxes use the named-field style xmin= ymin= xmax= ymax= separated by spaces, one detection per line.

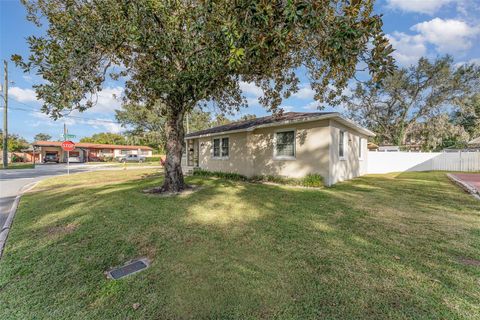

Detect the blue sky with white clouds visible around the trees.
xmin=0 ymin=0 xmax=480 ymax=141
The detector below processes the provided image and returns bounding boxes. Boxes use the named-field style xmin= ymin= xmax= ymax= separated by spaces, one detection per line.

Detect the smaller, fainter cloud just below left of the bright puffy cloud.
xmin=387 ymin=32 xmax=427 ymax=66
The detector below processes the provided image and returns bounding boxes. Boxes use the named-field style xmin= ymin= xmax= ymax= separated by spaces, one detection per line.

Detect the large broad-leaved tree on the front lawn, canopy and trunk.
xmin=13 ymin=0 xmax=392 ymax=191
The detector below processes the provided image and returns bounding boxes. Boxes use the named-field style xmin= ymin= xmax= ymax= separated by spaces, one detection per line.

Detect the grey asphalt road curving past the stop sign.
xmin=0 ymin=164 xmax=109 ymax=230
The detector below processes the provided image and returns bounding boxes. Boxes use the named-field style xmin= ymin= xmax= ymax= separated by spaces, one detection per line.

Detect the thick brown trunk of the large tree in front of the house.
xmin=158 ymin=111 xmax=185 ymax=192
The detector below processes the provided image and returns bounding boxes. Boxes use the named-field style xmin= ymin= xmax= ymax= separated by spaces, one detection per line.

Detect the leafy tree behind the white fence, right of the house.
xmin=345 ymin=56 xmax=480 ymax=150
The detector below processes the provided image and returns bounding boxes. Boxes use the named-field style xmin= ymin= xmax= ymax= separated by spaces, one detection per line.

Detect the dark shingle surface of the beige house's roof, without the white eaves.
xmin=186 ymin=112 xmax=336 ymax=138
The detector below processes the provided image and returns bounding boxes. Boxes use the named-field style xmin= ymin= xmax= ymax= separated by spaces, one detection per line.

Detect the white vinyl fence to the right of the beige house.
xmin=367 ymin=151 xmax=480 ymax=173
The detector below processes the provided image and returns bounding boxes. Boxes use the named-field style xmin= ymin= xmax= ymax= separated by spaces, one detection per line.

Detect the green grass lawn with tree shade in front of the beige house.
xmin=0 ymin=169 xmax=480 ymax=319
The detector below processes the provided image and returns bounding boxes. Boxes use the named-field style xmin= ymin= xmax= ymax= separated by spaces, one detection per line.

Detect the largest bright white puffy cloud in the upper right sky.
xmin=411 ymin=18 xmax=480 ymax=53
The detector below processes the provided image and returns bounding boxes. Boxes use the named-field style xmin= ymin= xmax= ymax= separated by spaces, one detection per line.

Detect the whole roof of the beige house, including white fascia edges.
xmin=185 ymin=112 xmax=375 ymax=139
